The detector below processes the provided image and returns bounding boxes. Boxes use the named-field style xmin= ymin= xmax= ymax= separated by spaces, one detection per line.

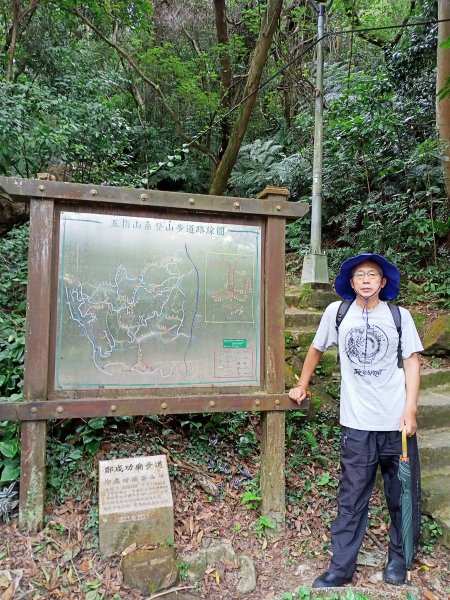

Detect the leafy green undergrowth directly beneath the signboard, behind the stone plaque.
xmin=42 ymin=411 xmax=339 ymax=509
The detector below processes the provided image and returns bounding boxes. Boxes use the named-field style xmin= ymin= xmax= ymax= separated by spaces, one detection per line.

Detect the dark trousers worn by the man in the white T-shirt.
xmin=329 ymin=427 xmax=420 ymax=578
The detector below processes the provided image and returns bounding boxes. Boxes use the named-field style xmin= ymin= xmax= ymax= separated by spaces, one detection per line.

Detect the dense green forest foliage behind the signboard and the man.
xmin=0 ymin=0 xmax=450 ymax=481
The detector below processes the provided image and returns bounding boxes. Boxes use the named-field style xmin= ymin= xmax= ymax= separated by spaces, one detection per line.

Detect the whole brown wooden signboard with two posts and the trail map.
xmin=0 ymin=178 xmax=308 ymax=531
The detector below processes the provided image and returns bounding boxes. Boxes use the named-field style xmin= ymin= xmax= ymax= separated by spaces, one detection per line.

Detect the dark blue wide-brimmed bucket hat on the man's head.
xmin=334 ymin=254 xmax=400 ymax=300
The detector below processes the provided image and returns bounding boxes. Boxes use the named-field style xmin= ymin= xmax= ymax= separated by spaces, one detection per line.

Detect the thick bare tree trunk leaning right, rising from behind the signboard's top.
xmin=209 ymin=0 xmax=283 ymax=196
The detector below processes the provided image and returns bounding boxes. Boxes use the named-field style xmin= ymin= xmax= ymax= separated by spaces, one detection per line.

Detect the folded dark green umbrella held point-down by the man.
xmin=398 ymin=427 xmax=413 ymax=585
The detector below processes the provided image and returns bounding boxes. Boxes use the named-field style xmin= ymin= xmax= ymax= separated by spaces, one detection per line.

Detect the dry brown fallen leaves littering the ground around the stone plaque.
xmin=0 ymin=418 xmax=450 ymax=600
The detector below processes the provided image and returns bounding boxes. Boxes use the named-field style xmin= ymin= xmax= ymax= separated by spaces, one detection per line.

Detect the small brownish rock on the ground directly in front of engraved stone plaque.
xmin=122 ymin=547 xmax=178 ymax=596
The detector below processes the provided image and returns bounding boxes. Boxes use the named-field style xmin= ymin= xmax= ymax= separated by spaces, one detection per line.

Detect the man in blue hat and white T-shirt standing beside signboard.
xmin=289 ymin=254 xmax=423 ymax=588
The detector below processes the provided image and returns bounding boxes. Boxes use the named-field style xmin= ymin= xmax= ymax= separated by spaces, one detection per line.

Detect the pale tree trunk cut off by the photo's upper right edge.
xmin=436 ymin=0 xmax=450 ymax=199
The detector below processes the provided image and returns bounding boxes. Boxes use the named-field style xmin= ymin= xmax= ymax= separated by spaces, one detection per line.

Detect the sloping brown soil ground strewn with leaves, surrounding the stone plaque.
xmin=0 ymin=415 xmax=450 ymax=600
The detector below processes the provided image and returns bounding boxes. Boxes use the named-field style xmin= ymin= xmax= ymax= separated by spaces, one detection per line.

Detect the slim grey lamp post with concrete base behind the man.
xmin=301 ymin=0 xmax=333 ymax=283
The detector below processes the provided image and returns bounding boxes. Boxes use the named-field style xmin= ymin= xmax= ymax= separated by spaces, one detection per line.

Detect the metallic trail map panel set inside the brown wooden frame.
xmin=55 ymin=212 xmax=261 ymax=389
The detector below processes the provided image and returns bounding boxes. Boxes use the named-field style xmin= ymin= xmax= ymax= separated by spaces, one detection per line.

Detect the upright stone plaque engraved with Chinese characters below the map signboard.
xmin=99 ymin=455 xmax=174 ymax=555
